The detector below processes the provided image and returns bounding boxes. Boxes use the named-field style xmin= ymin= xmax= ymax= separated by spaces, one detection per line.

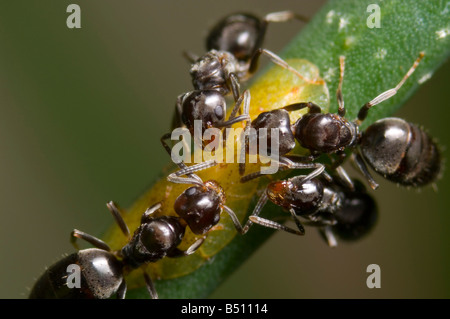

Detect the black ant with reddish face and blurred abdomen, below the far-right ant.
xmin=243 ymin=175 xmax=377 ymax=247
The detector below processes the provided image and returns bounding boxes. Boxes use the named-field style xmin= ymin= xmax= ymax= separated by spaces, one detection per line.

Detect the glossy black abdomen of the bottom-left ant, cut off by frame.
xmin=29 ymin=248 xmax=123 ymax=299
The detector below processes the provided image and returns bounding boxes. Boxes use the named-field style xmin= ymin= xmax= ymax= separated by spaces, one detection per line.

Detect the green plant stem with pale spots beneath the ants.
xmin=106 ymin=0 xmax=450 ymax=298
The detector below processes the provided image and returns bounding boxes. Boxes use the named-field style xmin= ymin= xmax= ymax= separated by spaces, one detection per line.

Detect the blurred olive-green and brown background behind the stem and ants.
xmin=0 ymin=0 xmax=450 ymax=298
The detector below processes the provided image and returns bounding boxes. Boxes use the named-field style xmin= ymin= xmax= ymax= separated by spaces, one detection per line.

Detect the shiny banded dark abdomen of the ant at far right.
xmin=360 ymin=118 xmax=441 ymax=187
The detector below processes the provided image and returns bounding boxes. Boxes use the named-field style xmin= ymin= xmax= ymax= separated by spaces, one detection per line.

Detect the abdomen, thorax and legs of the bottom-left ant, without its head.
xmin=29 ymin=202 xmax=203 ymax=299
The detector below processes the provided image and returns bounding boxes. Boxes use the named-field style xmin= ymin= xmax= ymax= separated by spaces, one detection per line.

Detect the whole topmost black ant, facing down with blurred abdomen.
xmin=173 ymin=11 xmax=322 ymax=141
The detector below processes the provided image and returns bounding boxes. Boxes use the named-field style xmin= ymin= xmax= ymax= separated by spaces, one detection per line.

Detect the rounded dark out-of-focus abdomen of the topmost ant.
xmin=206 ymin=13 xmax=265 ymax=62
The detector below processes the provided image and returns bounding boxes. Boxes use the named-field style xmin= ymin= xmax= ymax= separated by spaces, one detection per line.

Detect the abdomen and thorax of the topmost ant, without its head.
xmin=185 ymin=11 xmax=314 ymax=101
